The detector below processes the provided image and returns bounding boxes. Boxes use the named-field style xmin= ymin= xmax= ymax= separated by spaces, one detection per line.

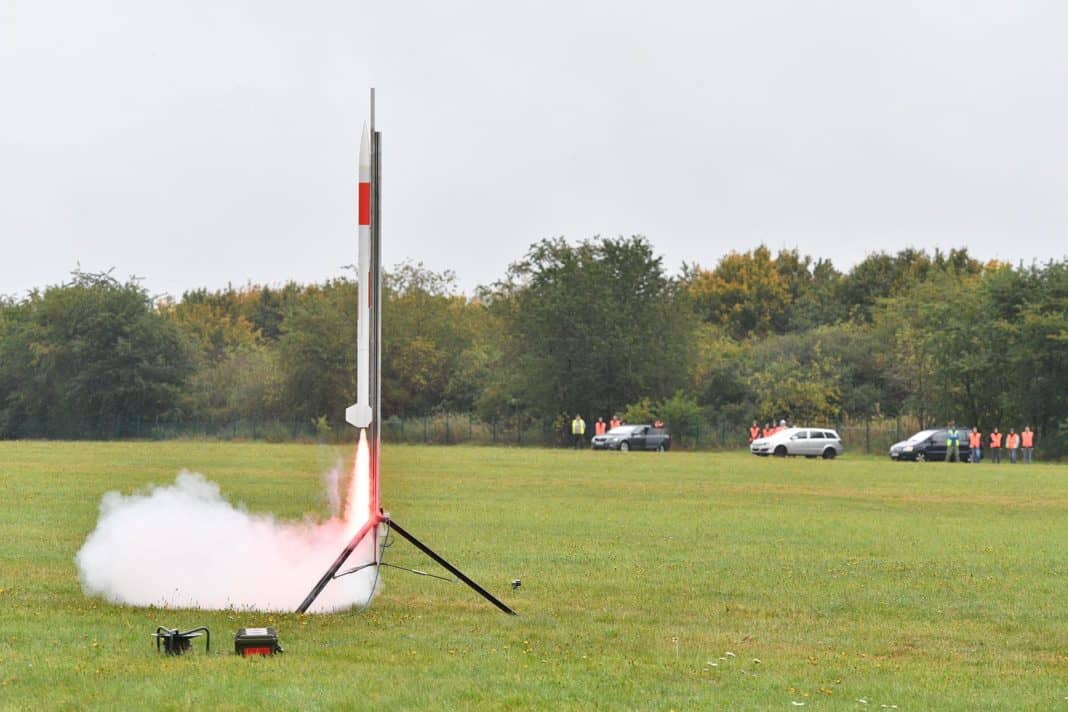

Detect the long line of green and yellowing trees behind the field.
xmin=0 ymin=242 xmax=1068 ymax=453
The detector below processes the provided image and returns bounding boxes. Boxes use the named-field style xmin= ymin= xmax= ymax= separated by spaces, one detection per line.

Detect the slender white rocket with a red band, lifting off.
xmin=345 ymin=124 xmax=376 ymax=429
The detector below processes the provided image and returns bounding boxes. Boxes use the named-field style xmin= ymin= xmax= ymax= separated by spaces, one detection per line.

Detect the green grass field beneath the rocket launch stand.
xmin=0 ymin=442 xmax=1068 ymax=710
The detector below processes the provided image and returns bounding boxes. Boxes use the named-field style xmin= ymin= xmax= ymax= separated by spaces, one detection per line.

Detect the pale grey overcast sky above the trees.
xmin=0 ymin=0 xmax=1068 ymax=295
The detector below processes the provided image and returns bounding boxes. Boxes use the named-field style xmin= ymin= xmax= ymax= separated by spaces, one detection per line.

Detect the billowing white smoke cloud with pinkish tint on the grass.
xmin=75 ymin=472 xmax=376 ymax=613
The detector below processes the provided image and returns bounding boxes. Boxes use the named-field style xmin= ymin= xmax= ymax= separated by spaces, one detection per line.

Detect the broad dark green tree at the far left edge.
xmin=0 ymin=271 xmax=192 ymax=438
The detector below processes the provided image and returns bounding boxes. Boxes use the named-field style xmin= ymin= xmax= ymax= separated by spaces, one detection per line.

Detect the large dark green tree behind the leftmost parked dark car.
xmin=489 ymin=236 xmax=692 ymax=415
